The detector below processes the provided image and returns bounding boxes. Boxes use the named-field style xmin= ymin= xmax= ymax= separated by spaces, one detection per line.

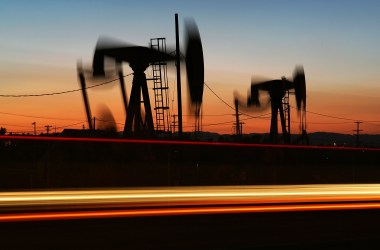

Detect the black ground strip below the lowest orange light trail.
xmin=0 ymin=210 xmax=380 ymax=250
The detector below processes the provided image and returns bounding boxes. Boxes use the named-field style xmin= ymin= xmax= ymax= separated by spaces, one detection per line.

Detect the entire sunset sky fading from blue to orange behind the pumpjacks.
xmin=0 ymin=0 xmax=380 ymax=134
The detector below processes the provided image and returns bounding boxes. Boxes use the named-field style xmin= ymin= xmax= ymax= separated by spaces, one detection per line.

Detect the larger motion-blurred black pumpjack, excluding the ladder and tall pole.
xmin=78 ymin=16 xmax=204 ymax=137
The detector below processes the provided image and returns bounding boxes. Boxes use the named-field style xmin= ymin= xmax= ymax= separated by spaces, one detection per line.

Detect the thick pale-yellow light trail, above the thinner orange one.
xmin=0 ymin=184 xmax=380 ymax=205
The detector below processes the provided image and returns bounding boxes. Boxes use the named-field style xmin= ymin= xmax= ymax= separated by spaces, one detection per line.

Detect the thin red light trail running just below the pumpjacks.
xmin=0 ymin=135 xmax=380 ymax=152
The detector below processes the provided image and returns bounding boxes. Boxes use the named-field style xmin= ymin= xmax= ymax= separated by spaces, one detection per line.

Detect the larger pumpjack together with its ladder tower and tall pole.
xmin=78 ymin=14 xmax=204 ymax=138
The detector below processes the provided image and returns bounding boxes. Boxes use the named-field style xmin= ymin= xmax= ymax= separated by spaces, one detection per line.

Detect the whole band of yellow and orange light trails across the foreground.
xmin=0 ymin=184 xmax=380 ymax=222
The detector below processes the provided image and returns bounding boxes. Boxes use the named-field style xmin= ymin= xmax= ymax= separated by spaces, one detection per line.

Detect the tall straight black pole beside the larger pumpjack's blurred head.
xmin=175 ymin=13 xmax=182 ymax=140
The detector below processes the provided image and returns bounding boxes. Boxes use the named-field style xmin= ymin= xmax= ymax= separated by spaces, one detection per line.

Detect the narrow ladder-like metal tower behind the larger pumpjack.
xmin=150 ymin=38 xmax=170 ymax=133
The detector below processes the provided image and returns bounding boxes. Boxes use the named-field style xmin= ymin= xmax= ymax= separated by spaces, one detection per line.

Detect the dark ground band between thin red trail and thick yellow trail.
xmin=0 ymin=137 xmax=380 ymax=190
